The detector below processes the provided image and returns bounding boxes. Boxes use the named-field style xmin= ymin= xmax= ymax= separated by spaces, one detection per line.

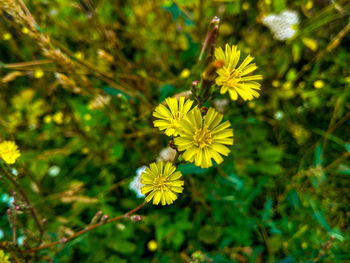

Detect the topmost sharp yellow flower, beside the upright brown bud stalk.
xmin=215 ymin=44 xmax=262 ymax=100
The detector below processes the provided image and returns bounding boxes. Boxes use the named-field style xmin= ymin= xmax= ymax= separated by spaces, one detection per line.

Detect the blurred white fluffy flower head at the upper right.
xmin=263 ymin=10 xmax=299 ymax=41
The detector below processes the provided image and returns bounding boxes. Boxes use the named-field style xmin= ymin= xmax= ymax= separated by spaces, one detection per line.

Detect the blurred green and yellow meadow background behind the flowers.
xmin=0 ymin=0 xmax=350 ymax=263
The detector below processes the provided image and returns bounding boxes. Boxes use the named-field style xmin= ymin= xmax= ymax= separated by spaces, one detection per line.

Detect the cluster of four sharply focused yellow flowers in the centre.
xmin=141 ymin=45 xmax=262 ymax=205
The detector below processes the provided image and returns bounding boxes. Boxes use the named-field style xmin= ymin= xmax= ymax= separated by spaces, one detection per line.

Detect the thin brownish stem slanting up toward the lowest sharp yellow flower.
xmin=23 ymin=202 xmax=146 ymax=253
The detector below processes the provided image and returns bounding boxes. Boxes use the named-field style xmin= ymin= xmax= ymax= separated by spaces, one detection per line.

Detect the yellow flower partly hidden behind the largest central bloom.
xmin=153 ymin=97 xmax=193 ymax=136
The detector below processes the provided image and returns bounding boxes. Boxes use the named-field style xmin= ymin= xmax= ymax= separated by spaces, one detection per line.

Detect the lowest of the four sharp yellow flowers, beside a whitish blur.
xmin=141 ymin=162 xmax=184 ymax=205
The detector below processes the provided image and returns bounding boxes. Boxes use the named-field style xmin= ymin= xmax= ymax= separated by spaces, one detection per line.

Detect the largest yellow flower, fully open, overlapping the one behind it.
xmin=175 ymin=107 xmax=233 ymax=168
